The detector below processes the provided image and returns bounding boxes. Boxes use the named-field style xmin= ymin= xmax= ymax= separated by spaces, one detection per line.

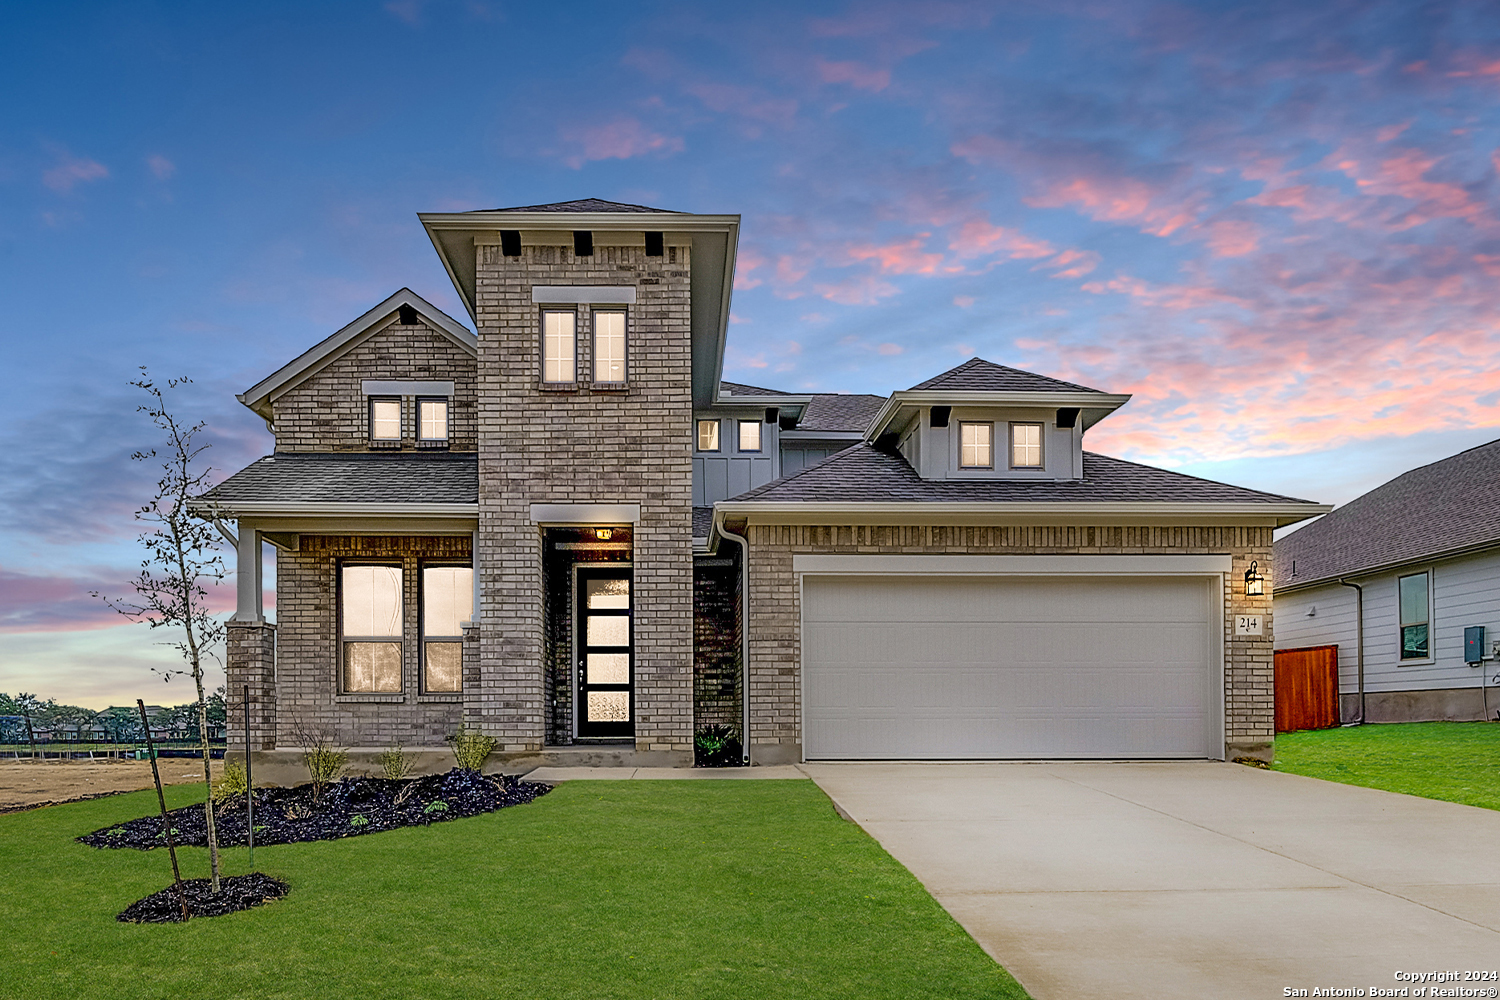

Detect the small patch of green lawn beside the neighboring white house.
xmin=1275 ymin=723 xmax=1500 ymax=810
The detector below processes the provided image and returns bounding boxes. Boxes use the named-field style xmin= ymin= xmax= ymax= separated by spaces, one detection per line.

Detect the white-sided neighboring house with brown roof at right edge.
xmin=1275 ymin=441 xmax=1500 ymax=723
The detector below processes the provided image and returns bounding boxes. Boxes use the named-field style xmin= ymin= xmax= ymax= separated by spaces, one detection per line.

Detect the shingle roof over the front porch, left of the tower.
xmin=204 ymin=451 xmax=479 ymax=510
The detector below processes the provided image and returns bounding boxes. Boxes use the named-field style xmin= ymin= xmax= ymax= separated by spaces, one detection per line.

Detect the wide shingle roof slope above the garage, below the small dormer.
xmin=731 ymin=444 xmax=1308 ymax=504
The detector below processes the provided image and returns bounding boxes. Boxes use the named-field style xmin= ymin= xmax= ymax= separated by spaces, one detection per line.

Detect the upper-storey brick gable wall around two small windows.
xmin=272 ymin=321 xmax=477 ymax=451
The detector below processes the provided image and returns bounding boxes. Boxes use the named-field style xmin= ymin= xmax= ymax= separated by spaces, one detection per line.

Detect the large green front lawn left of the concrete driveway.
xmin=0 ymin=781 xmax=1026 ymax=1000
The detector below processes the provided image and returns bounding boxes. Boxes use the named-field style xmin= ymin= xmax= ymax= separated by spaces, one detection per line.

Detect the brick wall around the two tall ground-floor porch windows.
xmin=276 ymin=535 xmax=471 ymax=748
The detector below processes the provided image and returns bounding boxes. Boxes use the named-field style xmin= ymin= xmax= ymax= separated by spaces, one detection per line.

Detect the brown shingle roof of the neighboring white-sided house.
xmin=1274 ymin=439 xmax=1500 ymax=586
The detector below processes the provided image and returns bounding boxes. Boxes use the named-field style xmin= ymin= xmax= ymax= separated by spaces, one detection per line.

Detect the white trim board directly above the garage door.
xmin=792 ymin=553 xmax=1233 ymax=576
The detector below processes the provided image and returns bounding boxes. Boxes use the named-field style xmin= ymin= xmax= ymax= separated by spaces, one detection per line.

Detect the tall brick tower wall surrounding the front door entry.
xmin=477 ymin=246 xmax=693 ymax=751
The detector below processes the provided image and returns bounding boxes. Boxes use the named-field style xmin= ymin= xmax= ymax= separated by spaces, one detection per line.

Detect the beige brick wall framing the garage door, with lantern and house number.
xmin=750 ymin=525 xmax=1275 ymax=759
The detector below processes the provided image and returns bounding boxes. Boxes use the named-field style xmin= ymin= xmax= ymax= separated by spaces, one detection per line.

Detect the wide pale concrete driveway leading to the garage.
xmin=803 ymin=762 xmax=1500 ymax=1000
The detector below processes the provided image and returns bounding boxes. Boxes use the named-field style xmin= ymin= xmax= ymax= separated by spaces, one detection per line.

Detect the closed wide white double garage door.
xmin=803 ymin=576 xmax=1223 ymax=760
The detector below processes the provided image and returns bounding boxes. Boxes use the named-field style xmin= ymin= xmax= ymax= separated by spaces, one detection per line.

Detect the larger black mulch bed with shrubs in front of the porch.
xmin=78 ymin=768 xmax=552 ymax=850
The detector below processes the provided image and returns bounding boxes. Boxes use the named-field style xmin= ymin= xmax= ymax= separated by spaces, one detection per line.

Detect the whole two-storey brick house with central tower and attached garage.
xmin=203 ymin=194 xmax=1328 ymax=777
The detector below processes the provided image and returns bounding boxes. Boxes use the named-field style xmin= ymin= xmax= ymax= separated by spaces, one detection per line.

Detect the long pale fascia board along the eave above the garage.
xmin=714 ymin=501 xmax=1332 ymax=528
